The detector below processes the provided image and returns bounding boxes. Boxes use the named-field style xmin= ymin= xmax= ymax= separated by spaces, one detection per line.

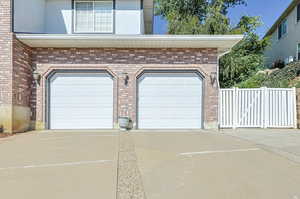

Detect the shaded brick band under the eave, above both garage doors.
xmin=33 ymin=48 xmax=217 ymax=64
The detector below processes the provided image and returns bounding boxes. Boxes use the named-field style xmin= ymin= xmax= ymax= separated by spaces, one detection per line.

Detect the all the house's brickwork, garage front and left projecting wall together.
xmin=0 ymin=0 xmax=218 ymax=132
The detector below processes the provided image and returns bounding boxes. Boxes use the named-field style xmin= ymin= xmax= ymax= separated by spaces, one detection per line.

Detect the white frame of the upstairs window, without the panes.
xmin=72 ymin=0 xmax=116 ymax=35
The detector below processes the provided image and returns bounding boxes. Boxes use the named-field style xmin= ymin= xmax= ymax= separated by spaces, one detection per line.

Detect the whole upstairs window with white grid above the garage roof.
xmin=74 ymin=0 xmax=114 ymax=33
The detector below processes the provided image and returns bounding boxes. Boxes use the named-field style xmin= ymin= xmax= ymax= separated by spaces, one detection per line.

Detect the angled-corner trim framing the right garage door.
xmin=135 ymin=69 xmax=206 ymax=130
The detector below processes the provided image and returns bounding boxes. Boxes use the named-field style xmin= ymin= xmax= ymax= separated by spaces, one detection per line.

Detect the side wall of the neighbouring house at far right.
xmin=265 ymin=8 xmax=300 ymax=66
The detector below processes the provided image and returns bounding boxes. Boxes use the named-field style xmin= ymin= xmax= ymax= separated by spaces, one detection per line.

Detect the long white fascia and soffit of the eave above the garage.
xmin=16 ymin=34 xmax=243 ymax=53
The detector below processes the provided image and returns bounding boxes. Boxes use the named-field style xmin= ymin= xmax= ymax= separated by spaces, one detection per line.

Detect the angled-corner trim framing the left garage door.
xmin=44 ymin=69 xmax=116 ymax=129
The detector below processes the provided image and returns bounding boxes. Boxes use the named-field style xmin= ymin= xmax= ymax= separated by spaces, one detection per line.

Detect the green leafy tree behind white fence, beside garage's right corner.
xmin=220 ymin=16 xmax=269 ymax=87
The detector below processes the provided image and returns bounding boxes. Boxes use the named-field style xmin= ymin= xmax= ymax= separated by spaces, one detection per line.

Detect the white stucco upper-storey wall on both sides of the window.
xmin=15 ymin=0 xmax=144 ymax=34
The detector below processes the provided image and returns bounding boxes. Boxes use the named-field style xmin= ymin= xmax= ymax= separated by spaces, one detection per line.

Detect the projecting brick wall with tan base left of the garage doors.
xmin=0 ymin=0 xmax=32 ymax=133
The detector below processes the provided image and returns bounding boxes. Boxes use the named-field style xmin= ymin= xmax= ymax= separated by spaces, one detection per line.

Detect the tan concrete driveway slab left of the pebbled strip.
xmin=0 ymin=132 xmax=118 ymax=199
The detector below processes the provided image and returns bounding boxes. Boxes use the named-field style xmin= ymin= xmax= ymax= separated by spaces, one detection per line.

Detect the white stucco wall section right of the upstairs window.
xmin=115 ymin=0 xmax=143 ymax=34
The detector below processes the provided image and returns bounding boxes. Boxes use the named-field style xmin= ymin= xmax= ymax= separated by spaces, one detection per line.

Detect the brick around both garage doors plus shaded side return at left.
xmin=1 ymin=39 xmax=218 ymax=129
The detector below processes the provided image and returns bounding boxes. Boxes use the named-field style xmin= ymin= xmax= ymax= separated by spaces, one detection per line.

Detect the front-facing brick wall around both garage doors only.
xmin=31 ymin=48 xmax=218 ymax=128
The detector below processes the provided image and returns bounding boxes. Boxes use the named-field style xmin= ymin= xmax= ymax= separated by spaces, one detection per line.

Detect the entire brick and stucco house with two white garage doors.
xmin=0 ymin=0 xmax=242 ymax=132
